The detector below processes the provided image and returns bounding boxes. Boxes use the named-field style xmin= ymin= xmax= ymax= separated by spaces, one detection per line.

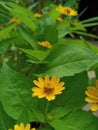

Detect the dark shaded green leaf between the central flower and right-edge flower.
xmin=53 ymin=72 xmax=88 ymax=109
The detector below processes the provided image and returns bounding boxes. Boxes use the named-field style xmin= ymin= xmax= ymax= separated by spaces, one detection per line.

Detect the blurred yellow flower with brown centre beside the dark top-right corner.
xmin=57 ymin=5 xmax=78 ymax=16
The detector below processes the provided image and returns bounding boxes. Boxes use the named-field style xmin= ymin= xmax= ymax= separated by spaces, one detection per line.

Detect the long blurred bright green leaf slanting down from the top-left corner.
xmin=1 ymin=2 xmax=37 ymax=31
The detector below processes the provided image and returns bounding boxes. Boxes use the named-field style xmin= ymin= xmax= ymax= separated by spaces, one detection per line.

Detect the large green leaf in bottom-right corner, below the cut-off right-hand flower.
xmin=49 ymin=111 xmax=98 ymax=130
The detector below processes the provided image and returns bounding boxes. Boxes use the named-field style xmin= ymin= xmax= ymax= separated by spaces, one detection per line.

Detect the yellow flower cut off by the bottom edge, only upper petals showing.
xmin=9 ymin=123 xmax=36 ymax=130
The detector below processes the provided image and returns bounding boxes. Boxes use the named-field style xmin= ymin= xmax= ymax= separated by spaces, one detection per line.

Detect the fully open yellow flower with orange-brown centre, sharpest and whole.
xmin=32 ymin=75 xmax=65 ymax=101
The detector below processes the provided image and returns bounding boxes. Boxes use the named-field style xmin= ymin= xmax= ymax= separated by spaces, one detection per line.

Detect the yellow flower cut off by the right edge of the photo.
xmin=85 ymin=80 xmax=98 ymax=111
